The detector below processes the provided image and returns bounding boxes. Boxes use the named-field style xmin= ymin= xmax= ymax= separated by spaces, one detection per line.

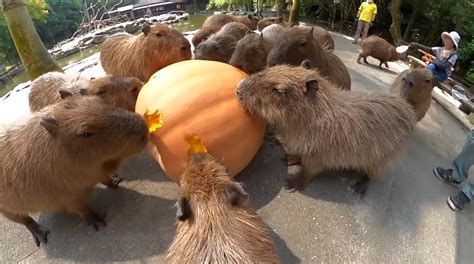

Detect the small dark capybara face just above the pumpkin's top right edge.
xmin=229 ymin=31 xmax=273 ymax=74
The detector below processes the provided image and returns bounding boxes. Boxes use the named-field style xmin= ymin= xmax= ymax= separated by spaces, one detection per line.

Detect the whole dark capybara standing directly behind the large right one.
xmin=267 ymin=27 xmax=351 ymax=90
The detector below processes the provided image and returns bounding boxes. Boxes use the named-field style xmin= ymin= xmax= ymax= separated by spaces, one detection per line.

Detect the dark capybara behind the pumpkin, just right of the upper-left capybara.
xmin=194 ymin=22 xmax=249 ymax=63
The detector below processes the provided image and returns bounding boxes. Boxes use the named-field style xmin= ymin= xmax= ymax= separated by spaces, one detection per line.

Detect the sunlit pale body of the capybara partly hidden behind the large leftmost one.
xmin=28 ymin=72 xmax=89 ymax=113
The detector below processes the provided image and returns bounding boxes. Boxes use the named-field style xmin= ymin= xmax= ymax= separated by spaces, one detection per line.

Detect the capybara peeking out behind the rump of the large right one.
xmin=390 ymin=69 xmax=435 ymax=121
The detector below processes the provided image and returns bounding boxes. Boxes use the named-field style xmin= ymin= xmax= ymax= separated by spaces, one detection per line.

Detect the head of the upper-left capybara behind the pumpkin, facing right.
xmin=140 ymin=23 xmax=192 ymax=71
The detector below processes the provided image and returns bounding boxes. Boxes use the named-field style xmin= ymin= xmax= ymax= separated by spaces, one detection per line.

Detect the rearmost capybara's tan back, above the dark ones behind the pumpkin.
xmin=191 ymin=14 xmax=259 ymax=47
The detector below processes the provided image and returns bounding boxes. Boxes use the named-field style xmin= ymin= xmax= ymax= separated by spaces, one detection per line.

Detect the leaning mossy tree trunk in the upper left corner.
xmin=0 ymin=0 xmax=62 ymax=80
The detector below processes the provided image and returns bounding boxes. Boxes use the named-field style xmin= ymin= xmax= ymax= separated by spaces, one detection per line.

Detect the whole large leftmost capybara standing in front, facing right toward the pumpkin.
xmin=0 ymin=96 xmax=148 ymax=246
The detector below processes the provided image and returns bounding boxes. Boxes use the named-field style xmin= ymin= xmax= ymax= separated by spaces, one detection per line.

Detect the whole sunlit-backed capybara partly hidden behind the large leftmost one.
xmin=28 ymin=72 xmax=143 ymax=112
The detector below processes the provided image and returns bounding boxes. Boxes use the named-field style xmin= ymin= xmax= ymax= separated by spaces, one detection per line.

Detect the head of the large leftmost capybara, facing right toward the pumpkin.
xmin=40 ymin=95 xmax=148 ymax=161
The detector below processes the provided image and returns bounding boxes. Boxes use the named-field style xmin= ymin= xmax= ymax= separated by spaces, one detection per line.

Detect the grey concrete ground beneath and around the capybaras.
xmin=0 ymin=32 xmax=474 ymax=263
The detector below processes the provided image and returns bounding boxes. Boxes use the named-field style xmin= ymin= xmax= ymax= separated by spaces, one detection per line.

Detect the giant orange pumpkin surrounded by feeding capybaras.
xmin=135 ymin=60 xmax=265 ymax=182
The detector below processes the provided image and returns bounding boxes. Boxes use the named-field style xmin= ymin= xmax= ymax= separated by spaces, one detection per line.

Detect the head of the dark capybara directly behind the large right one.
xmin=267 ymin=27 xmax=322 ymax=67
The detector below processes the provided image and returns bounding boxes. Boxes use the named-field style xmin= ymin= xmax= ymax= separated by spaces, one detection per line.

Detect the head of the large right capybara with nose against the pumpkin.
xmin=237 ymin=60 xmax=323 ymax=125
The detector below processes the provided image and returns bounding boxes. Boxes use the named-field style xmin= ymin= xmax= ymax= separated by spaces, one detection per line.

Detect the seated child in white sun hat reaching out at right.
xmin=410 ymin=31 xmax=461 ymax=82
